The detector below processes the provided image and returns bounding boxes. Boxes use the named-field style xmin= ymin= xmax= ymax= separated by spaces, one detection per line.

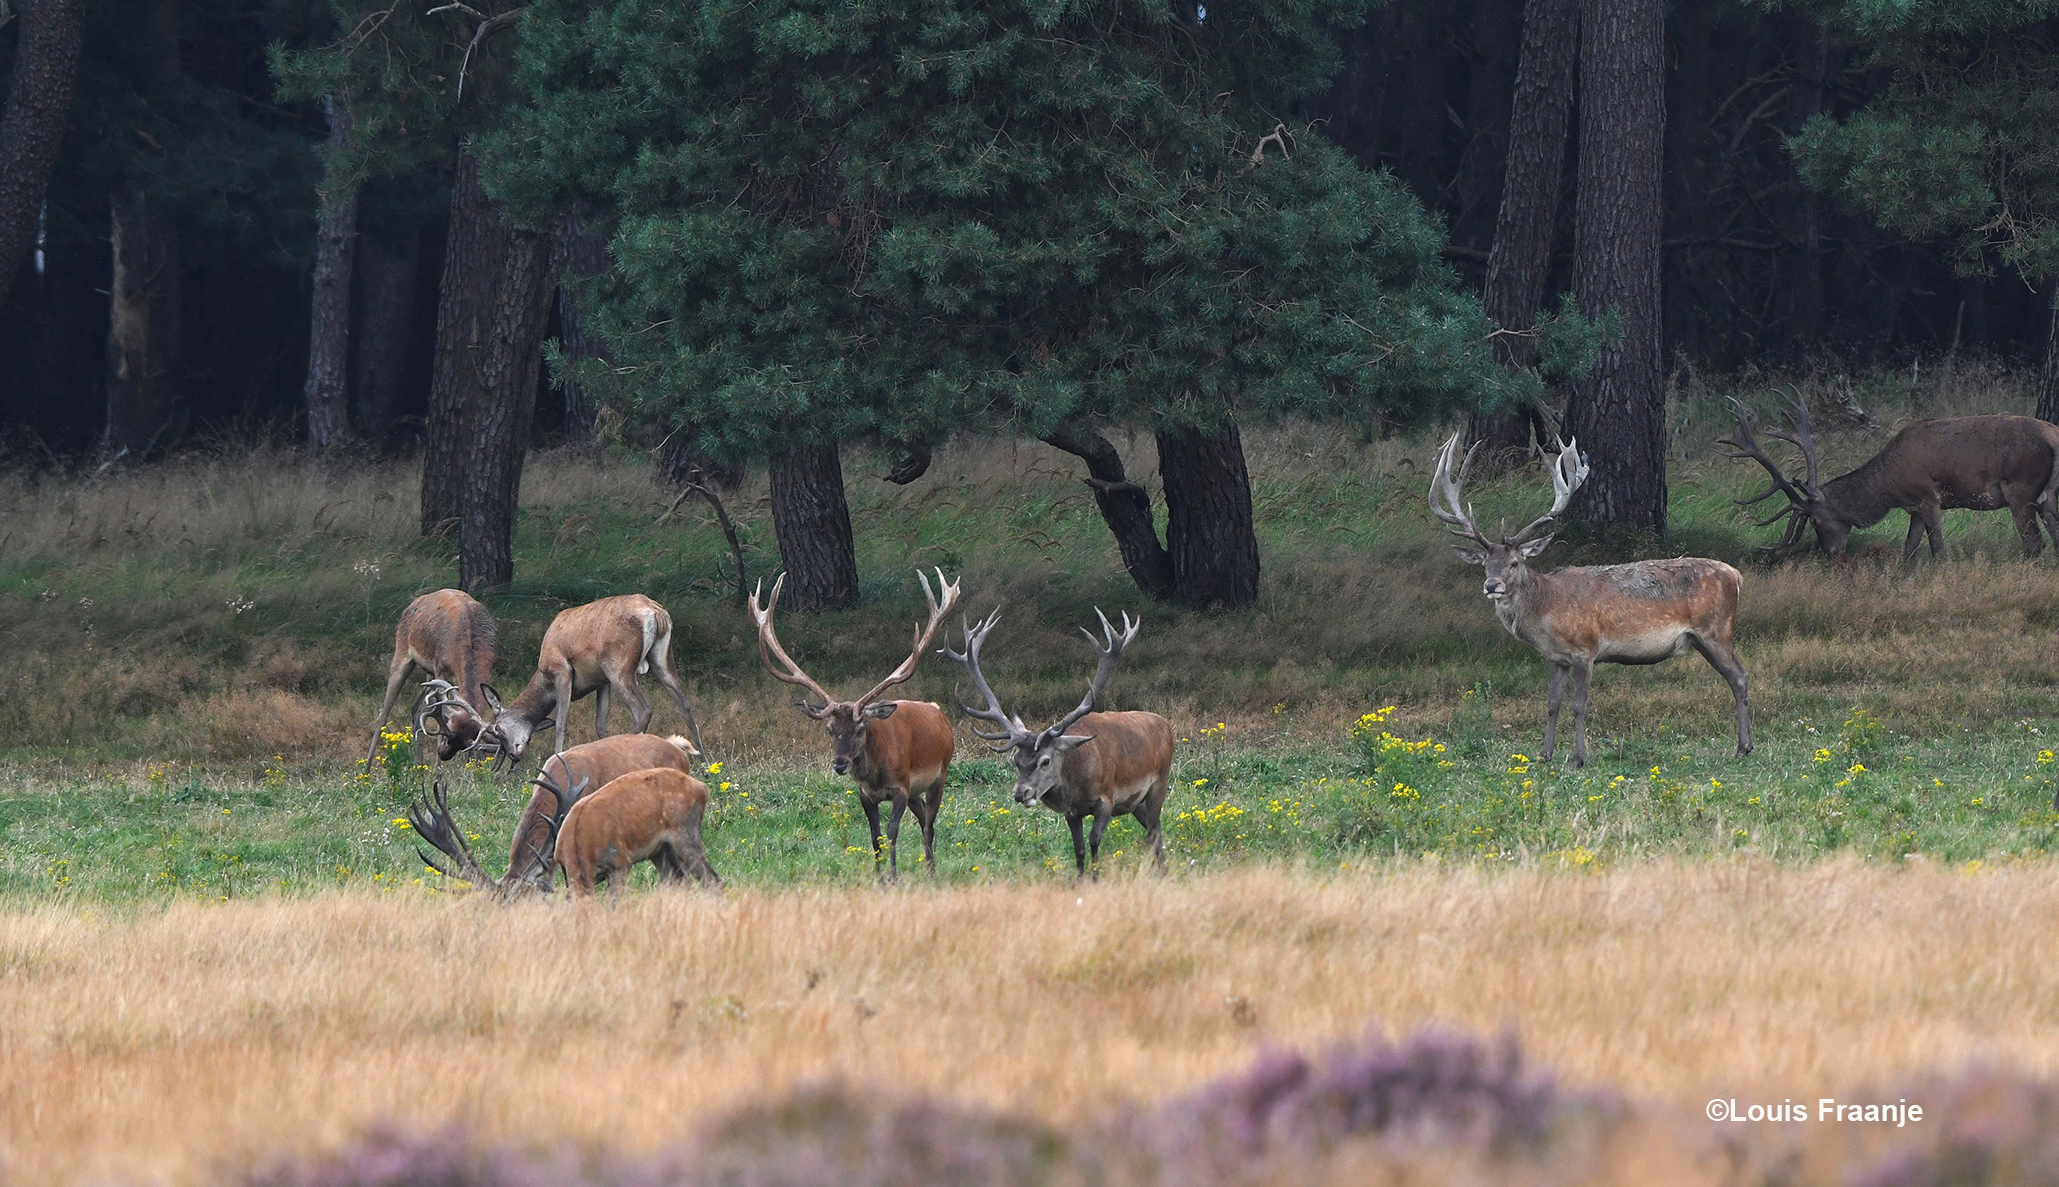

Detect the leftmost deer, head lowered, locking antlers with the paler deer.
xmin=364 ymin=589 xmax=496 ymax=762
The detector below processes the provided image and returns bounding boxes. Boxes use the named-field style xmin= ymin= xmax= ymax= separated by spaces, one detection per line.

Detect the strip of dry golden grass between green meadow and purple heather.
xmin=12 ymin=863 xmax=2059 ymax=1187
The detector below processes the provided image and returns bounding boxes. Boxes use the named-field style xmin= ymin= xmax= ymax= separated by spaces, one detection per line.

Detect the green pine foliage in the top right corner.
xmin=1791 ymin=0 xmax=2059 ymax=280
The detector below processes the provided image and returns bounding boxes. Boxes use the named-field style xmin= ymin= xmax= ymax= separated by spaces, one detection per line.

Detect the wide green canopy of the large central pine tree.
xmin=482 ymin=0 xmax=1530 ymax=455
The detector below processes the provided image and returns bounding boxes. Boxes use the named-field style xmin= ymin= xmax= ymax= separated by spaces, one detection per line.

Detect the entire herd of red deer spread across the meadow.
xmin=367 ymin=400 xmax=2059 ymax=898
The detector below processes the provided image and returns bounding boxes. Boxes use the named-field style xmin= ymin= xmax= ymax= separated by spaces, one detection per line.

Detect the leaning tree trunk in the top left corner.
xmin=0 ymin=0 xmax=86 ymax=299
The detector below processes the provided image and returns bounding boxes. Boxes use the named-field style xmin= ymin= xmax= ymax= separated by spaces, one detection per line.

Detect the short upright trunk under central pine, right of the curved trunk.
xmin=1157 ymin=425 xmax=1258 ymax=610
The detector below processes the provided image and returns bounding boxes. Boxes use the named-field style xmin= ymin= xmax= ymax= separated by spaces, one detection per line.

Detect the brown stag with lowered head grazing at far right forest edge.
xmin=1719 ymin=396 xmax=2059 ymax=563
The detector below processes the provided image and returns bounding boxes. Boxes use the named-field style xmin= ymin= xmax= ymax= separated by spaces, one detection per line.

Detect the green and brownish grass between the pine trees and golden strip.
xmin=12 ymin=354 xmax=2059 ymax=901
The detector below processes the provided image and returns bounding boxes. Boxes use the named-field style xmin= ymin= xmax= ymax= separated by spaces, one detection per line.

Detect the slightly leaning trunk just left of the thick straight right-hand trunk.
xmin=1472 ymin=0 xmax=1579 ymax=453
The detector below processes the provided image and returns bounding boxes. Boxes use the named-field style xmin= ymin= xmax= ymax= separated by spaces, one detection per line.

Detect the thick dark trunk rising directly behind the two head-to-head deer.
xmin=422 ymin=150 xmax=550 ymax=589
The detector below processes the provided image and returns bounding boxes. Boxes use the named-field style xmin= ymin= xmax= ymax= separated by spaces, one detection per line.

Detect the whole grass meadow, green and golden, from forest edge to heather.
xmin=0 ymin=363 xmax=2059 ymax=1187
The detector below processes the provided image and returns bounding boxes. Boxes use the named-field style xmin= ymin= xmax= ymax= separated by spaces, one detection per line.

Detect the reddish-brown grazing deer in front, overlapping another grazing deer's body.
xmin=556 ymin=767 xmax=723 ymax=898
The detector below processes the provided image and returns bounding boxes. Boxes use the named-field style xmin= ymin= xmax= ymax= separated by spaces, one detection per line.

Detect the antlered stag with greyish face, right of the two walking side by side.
xmin=943 ymin=608 xmax=1172 ymax=876
